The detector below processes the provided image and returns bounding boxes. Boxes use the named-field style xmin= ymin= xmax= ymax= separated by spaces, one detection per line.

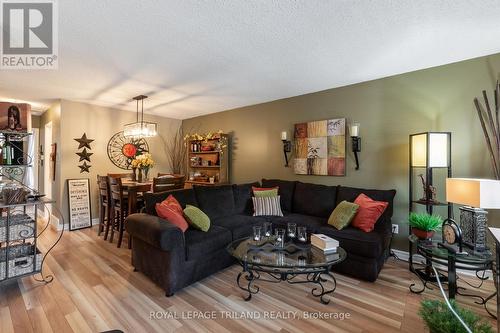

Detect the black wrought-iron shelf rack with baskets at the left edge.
xmin=0 ymin=131 xmax=60 ymax=283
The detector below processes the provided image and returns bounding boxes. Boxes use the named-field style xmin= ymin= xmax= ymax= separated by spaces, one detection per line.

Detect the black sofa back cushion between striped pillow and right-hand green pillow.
xmin=292 ymin=182 xmax=338 ymax=218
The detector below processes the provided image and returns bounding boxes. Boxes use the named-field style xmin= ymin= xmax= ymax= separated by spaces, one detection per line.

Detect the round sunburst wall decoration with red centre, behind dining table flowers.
xmin=108 ymin=131 xmax=149 ymax=170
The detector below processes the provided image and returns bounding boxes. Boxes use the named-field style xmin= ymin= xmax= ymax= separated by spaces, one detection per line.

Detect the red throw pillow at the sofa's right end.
xmin=351 ymin=193 xmax=389 ymax=232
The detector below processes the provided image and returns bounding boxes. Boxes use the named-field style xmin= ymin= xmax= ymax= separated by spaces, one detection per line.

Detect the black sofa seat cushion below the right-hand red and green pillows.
xmin=318 ymin=226 xmax=384 ymax=258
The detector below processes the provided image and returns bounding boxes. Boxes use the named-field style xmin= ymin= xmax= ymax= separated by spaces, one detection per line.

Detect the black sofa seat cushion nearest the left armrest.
xmin=184 ymin=225 xmax=232 ymax=260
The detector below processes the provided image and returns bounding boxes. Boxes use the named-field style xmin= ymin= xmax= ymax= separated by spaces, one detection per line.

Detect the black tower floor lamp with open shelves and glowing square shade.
xmin=408 ymin=132 xmax=453 ymax=277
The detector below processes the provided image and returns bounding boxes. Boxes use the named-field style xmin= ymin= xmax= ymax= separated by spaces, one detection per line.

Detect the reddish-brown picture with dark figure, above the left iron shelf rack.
xmin=0 ymin=102 xmax=31 ymax=133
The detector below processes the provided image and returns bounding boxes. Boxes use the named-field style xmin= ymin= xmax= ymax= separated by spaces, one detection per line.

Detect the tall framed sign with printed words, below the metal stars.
xmin=67 ymin=178 xmax=92 ymax=231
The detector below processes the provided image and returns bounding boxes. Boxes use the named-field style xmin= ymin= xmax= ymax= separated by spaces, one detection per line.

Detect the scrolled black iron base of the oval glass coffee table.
xmin=236 ymin=264 xmax=337 ymax=304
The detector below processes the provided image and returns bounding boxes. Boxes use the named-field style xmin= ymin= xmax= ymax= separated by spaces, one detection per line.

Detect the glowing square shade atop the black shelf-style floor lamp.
xmin=410 ymin=132 xmax=450 ymax=168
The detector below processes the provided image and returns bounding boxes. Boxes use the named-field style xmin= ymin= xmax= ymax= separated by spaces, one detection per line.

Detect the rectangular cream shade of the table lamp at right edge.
xmin=446 ymin=178 xmax=500 ymax=209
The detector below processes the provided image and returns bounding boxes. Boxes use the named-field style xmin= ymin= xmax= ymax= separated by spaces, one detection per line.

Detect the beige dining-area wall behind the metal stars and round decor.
xmin=40 ymin=100 xmax=181 ymax=223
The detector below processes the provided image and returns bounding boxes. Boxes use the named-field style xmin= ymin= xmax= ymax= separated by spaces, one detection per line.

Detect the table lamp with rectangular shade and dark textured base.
xmin=446 ymin=178 xmax=500 ymax=252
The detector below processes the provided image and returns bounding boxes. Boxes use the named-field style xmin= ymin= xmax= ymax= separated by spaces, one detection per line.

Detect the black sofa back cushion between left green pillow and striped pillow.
xmin=194 ymin=185 xmax=234 ymax=220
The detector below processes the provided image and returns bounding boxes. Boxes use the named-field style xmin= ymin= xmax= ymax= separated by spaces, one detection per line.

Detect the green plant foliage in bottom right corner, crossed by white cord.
xmin=418 ymin=299 xmax=493 ymax=333
